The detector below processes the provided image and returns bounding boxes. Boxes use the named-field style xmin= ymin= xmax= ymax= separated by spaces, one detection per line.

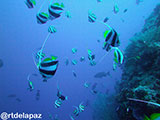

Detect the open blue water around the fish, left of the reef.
xmin=0 ymin=0 xmax=159 ymax=120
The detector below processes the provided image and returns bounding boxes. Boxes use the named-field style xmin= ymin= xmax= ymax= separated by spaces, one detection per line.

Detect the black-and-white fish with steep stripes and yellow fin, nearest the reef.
xmin=103 ymin=29 xmax=120 ymax=51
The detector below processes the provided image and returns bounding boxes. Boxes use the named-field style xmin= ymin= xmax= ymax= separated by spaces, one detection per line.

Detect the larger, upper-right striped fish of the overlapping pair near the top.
xmin=48 ymin=3 xmax=64 ymax=20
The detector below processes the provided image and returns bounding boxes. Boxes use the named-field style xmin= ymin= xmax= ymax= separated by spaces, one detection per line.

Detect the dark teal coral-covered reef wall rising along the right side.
xmin=115 ymin=4 xmax=160 ymax=120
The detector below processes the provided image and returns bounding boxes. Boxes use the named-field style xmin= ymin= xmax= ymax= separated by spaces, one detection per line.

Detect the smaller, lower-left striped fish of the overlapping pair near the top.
xmin=36 ymin=12 xmax=49 ymax=24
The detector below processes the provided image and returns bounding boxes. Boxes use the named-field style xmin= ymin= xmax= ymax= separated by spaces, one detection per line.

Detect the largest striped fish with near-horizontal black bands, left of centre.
xmin=39 ymin=56 xmax=58 ymax=81
